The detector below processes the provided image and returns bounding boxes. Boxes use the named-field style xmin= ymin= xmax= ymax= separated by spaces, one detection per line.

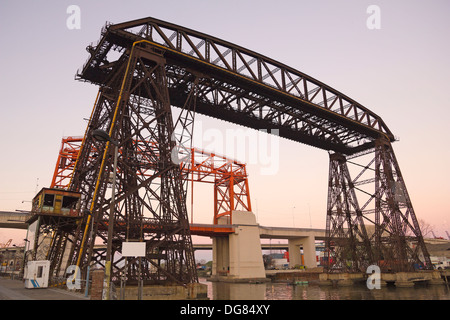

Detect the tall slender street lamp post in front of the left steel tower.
xmin=92 ymin=129 xmax=119 ymax=300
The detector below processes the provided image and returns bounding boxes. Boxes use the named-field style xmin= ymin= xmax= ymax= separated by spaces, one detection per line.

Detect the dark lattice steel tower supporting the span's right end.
xmin=326 ymin=139 xmax=432 ymax=272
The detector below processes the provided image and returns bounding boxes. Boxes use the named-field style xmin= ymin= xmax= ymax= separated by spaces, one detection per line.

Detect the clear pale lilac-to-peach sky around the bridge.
xmin=0 ymin=0 xmax=450 ymax=244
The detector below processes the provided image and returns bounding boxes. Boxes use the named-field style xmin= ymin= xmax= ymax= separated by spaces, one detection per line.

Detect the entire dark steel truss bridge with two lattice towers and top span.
xmin=26 ymin=18 xmax=431 ymax=284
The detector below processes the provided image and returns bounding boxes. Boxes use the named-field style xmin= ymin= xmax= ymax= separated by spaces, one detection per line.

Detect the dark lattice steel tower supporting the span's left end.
xmin=68 ymin=46 xmax=198 ymax=284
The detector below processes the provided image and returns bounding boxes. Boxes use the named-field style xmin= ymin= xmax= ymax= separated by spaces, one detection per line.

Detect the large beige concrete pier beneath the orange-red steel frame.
xmin=211 ymin=211 xmax=267 ymax=282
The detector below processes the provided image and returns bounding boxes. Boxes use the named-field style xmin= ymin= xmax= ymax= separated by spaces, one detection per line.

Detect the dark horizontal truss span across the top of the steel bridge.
xmin=77 ymin=18 xmax=394 ymax=155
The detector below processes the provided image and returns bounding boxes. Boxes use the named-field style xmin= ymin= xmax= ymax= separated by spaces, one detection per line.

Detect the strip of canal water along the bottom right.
xmin=199 ymin=278 xmax=450 ymax=300
